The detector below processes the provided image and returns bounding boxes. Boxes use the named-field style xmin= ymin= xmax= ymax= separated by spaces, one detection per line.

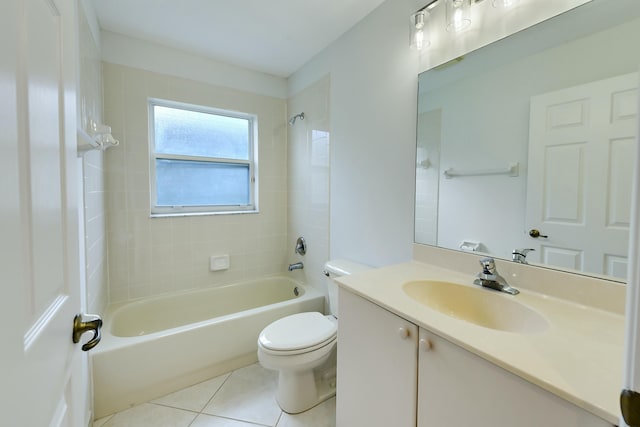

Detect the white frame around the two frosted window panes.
xmin=147 ymin=98 xmax=258 ymax=217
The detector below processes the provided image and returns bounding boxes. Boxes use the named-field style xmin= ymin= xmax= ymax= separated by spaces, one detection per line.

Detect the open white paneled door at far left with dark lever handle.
xmin=0 ymin=0 xmax=87 ymax=427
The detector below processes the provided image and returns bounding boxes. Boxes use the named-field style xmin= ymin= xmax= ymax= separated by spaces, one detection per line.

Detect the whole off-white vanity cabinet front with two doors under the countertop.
xmin=336 ymin=288 xmax=611 ymax=427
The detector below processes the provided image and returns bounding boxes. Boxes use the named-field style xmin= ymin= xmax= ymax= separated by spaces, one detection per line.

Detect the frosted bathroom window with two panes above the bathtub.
xmin=149 ymin=99 xmax=256 ymax=215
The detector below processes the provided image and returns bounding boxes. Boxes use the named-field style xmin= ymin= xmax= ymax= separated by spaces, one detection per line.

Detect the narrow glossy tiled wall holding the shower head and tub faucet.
xmin=287 ymin=76 xmax=330 ymax=296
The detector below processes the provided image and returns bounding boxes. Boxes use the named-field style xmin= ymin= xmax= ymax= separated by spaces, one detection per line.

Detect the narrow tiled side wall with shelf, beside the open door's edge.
xmin=78 ymin=4 xmax=108 ymax=313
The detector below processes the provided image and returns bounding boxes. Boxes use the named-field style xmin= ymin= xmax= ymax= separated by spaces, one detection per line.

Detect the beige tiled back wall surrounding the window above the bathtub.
xmin=103 ymin=63 xmax=293 ymax=303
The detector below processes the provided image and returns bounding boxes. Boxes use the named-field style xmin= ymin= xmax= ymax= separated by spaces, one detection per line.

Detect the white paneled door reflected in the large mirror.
xmin=526 ymin=73 xmax=638 ymax=278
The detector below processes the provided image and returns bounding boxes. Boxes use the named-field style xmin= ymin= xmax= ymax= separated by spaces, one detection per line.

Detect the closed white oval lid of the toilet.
xmin=258 ymin=312 xmax=338 ymax=351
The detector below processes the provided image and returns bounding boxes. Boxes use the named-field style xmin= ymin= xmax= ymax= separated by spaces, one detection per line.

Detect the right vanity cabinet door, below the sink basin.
xmin=418 ymin=329 xmax=611 ymax=427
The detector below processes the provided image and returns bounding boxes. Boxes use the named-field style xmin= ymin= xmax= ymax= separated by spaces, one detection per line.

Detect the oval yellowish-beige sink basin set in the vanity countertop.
xmin=403 ymin=280 xmax=549 ymax=333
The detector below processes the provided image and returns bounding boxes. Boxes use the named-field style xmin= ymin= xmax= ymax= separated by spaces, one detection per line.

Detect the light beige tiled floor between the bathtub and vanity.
xmin=93 ymin=364 xmax=336 ymax=427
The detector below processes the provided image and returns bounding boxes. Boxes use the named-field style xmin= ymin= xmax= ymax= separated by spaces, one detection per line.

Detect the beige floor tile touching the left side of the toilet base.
xmin=202 ymin=364 xmax=282 ymax=426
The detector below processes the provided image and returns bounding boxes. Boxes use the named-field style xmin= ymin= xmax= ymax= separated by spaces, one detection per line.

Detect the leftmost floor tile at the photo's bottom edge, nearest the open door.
xmin=104 ymin=403 xmax=197 ymax=427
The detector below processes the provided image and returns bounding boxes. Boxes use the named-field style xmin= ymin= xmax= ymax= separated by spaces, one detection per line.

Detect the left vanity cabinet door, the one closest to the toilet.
xmin=336 ymin=289 xmax=418 ymax=427
